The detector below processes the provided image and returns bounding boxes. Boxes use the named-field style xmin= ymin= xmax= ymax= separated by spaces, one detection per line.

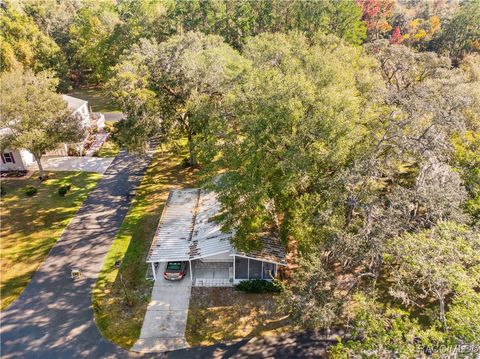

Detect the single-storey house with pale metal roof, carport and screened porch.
xmin=147 ymin=189 xmax=287 ymax=286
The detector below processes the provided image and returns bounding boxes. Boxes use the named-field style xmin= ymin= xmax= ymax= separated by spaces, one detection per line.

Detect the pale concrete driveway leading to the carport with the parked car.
xmin=131 ymin=263 xmax=192 ymax=353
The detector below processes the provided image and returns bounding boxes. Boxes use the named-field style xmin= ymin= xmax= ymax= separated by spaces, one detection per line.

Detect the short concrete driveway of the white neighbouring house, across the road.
xmin=30 ymin=156 xmax=113 ymax=173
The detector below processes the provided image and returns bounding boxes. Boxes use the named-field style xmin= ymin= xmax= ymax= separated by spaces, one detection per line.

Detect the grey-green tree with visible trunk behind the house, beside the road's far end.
xmin=112 ymin=32 xmax=248 ymax=166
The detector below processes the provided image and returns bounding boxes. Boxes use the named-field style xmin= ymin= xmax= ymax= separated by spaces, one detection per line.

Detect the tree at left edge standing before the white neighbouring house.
xmin=0 ymin=70 xmax=84 ymax=179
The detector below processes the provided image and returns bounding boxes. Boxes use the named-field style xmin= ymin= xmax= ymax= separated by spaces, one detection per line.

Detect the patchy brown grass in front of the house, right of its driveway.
xmin=185 ymin=287 xmax=293 ymax=346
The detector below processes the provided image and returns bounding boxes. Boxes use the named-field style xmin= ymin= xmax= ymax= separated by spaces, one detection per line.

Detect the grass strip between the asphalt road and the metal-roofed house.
xmin=93 ymin=143 xmax=195 ymax=349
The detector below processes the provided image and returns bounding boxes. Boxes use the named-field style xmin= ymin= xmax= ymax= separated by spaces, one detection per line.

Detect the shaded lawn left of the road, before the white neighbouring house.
xmin=0 ymin=172 xmax=101 ymax=310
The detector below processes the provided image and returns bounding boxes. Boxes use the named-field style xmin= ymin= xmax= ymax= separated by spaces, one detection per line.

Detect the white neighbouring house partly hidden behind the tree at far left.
xmin=0 ymin=95 xmax=103 ymax=171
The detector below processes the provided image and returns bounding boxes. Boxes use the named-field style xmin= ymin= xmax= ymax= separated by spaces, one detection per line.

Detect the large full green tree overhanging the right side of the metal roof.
xmin=204 ymin=33 xmax=381 ymax=252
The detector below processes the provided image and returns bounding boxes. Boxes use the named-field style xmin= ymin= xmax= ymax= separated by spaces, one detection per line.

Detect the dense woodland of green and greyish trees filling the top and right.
xmin=0 ymin=0 xmax=480 ymax=358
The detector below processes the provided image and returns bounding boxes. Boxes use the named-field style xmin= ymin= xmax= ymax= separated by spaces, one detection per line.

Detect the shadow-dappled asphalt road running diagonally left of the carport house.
xmin=0 ymin=153 xmax=149 ymax=359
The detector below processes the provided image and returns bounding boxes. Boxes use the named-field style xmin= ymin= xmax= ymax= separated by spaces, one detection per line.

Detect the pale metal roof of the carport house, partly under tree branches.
xmin=147 ymin=189 xmax=286 ymax=265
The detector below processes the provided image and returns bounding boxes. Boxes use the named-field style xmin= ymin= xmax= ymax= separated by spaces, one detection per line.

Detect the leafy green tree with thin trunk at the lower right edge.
xmin=387 ymin=222 xmax=480 ymax=331
